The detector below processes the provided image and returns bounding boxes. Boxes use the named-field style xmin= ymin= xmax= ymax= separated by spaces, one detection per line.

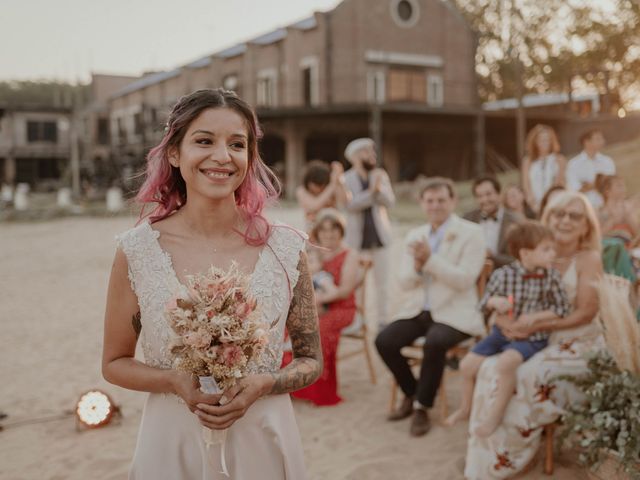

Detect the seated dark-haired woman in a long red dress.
xmin=291 ymin=209 xmax=360 ymax=406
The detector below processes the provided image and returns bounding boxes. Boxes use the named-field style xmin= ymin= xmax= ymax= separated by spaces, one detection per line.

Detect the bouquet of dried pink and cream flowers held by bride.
xmin=165 ymin=262 xmax=267 ymax=393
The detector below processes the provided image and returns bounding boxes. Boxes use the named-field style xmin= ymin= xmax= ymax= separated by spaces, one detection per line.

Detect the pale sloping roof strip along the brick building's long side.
xmin=111 ymin=15 xmax=318 ymax=98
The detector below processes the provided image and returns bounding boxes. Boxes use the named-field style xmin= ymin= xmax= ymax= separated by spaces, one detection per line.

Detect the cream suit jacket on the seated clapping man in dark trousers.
xmin=394 ymin=215 xmax=486 ymax=335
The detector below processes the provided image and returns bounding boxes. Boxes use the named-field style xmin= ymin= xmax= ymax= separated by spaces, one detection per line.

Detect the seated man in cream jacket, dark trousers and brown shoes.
xmin=376 ymin=178 xmax=486 ymax=437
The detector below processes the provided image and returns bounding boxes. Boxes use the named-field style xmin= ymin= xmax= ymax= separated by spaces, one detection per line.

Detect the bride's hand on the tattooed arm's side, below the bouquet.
xmin=195 ymin=375 xmax=274 ymax=430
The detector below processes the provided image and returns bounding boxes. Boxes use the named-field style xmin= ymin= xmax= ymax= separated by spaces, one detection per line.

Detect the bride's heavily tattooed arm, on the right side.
xmin=271 ymin=253 xmax=322 ymax=394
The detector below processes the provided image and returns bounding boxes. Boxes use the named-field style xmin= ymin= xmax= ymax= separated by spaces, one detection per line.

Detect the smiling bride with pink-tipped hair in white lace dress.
xmin=102 ymin=89 xmax=322 ymax=480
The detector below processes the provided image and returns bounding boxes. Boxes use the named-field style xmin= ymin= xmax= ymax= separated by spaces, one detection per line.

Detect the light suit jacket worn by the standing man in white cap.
xmin=344 ymin=168 xmax=396 ymax=250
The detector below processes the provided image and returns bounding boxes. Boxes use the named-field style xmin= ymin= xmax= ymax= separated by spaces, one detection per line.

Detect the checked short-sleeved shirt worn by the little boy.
xmin=479 ymin=260 xmax=571 ymax=341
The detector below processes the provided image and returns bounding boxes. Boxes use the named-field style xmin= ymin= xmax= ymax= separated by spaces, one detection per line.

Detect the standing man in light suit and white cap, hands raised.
xmin=344 ymin=138 xmax=396 ymax=329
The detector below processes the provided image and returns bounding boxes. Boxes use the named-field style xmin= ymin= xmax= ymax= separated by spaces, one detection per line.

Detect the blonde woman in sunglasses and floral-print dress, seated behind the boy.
xmin=465 ymin=191 xmax=605 ymax=480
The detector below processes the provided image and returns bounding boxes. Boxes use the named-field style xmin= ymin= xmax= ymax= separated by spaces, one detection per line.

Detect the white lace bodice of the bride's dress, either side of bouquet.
xmin=116 ymin=222 xmax=306 ymax=373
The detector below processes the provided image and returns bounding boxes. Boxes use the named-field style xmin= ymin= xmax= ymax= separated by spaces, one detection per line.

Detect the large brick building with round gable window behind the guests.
xmin=110 ymin=0 xmax=484 ymax=197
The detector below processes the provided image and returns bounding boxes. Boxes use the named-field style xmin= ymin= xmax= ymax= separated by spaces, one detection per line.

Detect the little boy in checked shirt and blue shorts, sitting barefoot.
xmin=445 ymin=221 xmax=571 ymax=437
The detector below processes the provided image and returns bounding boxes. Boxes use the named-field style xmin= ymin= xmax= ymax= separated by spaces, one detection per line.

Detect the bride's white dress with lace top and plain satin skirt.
xmin=117 ymin=222 xmax=306 ymax=480
